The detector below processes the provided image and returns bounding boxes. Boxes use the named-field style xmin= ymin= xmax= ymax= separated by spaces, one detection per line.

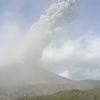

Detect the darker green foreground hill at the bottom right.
xmin=16 ymin=86 xmax=100 ymax=100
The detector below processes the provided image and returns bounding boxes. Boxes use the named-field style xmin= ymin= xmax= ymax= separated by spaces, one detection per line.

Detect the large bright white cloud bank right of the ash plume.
xmin=41 ymin=35 xmax=100 ymax=69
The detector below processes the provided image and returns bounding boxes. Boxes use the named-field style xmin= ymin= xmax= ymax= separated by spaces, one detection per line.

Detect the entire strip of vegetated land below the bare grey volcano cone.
xmin=0 ymin=80 xmax=100 ymax=100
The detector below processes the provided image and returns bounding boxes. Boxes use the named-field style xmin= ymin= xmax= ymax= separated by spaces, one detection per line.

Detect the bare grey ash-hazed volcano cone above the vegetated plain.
xmin=0 ymin=64 xmax=72 ymax=86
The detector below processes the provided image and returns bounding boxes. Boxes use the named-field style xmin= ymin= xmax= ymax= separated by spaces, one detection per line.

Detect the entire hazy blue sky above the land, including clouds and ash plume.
xmin=0 ymin=0 xmax=100 ymax=79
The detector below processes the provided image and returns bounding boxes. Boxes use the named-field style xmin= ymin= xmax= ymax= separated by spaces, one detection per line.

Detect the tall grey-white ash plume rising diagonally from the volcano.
xmin=0 ymin=0 xmax=77 ymax=66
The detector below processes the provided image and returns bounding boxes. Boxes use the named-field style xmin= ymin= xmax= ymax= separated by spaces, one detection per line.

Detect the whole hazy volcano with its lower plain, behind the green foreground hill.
xmin=0 ymin=64 xmax=100 ymax=100
